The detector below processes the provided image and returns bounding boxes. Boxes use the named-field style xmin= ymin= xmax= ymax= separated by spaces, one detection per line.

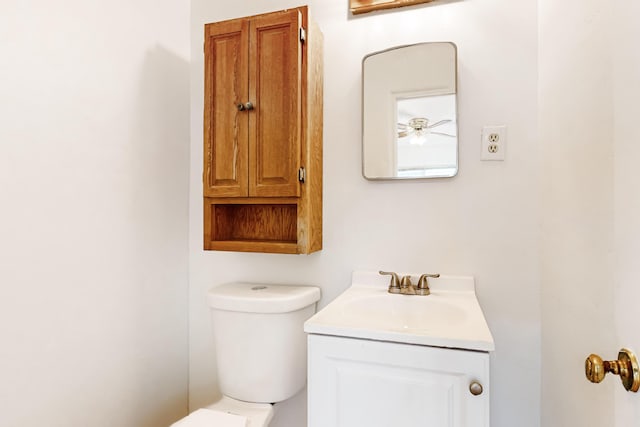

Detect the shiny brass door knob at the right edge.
xmin=584 ymin=348 xmax=640 ymax=392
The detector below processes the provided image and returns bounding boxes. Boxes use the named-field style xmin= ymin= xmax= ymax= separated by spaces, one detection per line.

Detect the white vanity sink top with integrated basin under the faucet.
xmin=304 ymin=272 xmax=494 ymax=351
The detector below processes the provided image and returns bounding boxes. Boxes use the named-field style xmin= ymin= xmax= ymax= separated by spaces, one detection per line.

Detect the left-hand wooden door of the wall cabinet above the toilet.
xmin=203 ymin=16 xmax=249 ymax=197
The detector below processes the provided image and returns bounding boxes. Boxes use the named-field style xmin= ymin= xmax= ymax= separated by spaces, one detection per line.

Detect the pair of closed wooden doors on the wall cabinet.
xmin=204 ymin=10 xmax=302 ymax=197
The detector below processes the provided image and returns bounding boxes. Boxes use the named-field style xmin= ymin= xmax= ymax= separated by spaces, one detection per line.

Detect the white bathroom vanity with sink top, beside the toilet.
xmin=304 ymin=271 xmax=495 ymax=427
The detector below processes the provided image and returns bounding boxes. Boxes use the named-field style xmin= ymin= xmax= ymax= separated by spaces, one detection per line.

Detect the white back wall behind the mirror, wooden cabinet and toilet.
xmin=190 ymin=0 xmax=540 ymax=427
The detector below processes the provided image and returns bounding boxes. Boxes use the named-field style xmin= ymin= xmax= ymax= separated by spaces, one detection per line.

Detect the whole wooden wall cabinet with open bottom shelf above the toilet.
xmin=203 ymin=6 xmax=323 ymax=253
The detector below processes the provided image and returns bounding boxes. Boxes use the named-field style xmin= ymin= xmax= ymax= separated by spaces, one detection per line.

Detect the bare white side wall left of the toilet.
xmin=0 ymin=0 xmax=190 ymax=427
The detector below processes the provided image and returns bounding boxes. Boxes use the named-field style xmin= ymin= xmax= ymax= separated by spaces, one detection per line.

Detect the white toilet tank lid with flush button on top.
xmin=207 ymin=282 xmax=320 ymax=313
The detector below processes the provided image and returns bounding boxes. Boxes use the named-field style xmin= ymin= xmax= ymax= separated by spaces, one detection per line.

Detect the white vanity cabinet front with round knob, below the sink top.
xmin=308 ymin=335 xmax=489 ymax=427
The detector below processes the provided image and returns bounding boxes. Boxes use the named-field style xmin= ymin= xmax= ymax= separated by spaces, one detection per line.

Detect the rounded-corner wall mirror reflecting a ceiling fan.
xmin=362 ymin=42 xmax=458 ymax=180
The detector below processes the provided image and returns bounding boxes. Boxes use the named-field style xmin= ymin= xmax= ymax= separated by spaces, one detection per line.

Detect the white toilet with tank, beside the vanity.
xmin=172 ymin=283 xmax=320 ymax=427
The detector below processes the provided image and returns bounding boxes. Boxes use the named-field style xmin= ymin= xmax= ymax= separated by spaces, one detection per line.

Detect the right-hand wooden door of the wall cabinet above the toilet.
xmin=249 ymin=10 xmax=302 ymax=197
